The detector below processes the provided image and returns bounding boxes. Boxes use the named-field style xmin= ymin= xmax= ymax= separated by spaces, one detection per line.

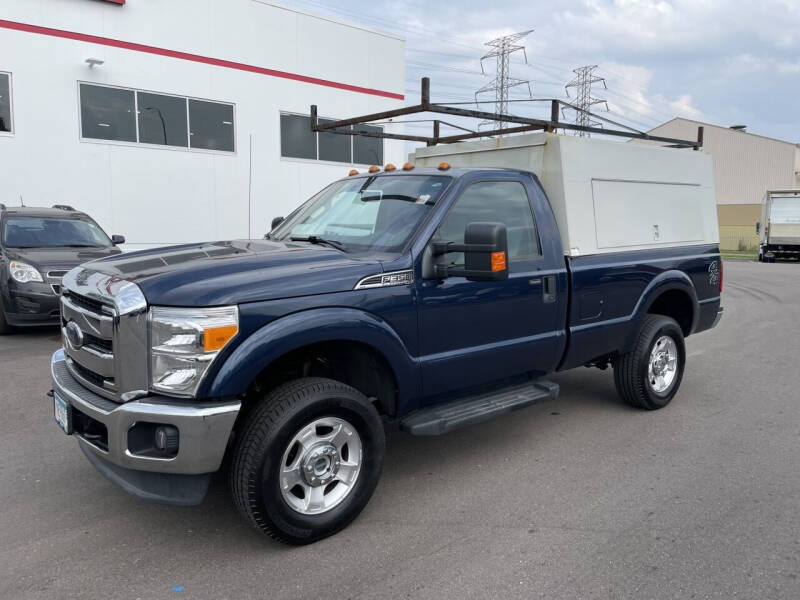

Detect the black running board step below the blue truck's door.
xmin=400 ymin=379 xmax=558 ymax=435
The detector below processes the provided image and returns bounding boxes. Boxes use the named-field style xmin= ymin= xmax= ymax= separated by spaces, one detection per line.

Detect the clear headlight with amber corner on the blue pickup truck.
xmin=150 ymin=306 xmax=239 ymax=396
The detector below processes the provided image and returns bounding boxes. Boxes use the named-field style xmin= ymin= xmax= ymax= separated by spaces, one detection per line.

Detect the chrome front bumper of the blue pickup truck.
xmin=50 ymin=350 xmax=241 ymax=504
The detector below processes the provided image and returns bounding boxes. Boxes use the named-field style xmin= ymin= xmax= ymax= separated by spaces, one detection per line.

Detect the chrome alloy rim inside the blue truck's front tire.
xmin=279 ymin=417 xmax=363 ymax=515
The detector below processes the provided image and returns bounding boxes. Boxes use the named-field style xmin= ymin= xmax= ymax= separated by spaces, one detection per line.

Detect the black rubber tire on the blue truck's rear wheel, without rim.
xmin=614 ymin=315 xmax=686 ymax=410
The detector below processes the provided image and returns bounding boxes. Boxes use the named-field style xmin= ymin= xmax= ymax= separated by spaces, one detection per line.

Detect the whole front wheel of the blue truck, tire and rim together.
xmin=230 ymin=377 xmax=385 ymax=544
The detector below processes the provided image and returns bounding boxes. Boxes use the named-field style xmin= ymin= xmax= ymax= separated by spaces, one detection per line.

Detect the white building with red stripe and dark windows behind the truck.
xmin=0 ymin=0 xmax=405 ymax=249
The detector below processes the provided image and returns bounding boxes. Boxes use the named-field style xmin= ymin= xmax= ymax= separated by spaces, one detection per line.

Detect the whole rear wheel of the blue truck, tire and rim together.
xmin=614 ymin=315 xmax=686 ymax=410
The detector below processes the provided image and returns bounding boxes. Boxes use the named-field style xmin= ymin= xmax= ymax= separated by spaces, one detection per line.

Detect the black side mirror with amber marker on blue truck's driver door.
xmin=431 ymin=223 xmax=508 ymax=281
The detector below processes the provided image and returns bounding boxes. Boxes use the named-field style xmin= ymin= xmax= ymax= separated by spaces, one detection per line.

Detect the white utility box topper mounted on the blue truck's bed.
xmin=409 ymin=133 xmax=719 ymax=256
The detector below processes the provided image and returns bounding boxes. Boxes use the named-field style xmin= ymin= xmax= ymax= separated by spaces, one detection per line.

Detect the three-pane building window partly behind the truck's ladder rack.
xmin=280 ymin=113 xmax=383 ymax=165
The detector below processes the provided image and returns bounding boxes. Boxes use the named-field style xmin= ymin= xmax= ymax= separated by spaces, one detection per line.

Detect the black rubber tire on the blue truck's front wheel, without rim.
xmin=230 ymin=377 xmax=385 ymax=545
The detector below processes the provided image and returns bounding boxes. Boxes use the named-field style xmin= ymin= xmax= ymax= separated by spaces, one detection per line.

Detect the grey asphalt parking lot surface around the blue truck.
xmin=0 ymin=261 xmax=800 ymax=599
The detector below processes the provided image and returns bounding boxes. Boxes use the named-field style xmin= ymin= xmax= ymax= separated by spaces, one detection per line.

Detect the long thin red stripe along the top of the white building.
xmin=0 ymin=19 xmax=405 ymax=100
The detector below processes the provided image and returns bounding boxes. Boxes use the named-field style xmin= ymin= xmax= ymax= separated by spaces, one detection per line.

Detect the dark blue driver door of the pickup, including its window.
xmin=417 ymin=173 xmax=563 ymax=396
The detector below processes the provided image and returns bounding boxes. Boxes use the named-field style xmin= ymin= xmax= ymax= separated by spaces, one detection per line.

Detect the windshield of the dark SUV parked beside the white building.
xmin=3 ymin=217 xmax=111 ymax=248
